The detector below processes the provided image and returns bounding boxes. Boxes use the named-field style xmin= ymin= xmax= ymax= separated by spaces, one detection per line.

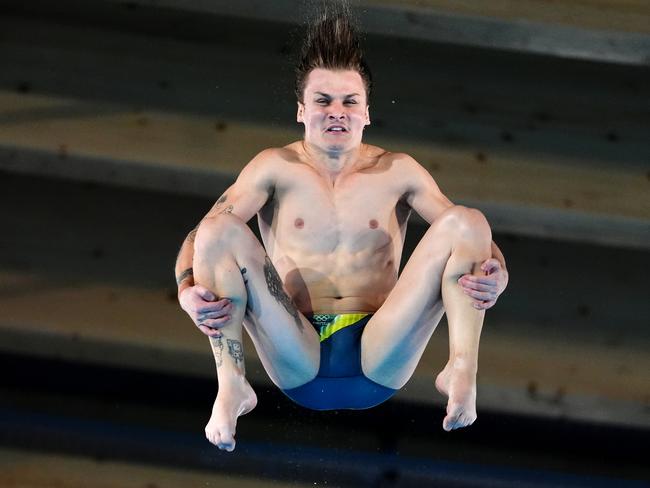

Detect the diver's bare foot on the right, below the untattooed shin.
xmin=436 ymin=359 xmax=476 ymax=431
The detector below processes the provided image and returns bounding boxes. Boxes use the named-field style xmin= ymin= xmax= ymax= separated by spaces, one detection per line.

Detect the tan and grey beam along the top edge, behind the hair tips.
xmin=88 ymin=0 xmax=650 ymax=65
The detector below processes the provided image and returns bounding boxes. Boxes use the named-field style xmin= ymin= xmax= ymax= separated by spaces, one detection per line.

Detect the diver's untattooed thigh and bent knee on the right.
xmin=361 ymin=206 xmax=490 ymax=388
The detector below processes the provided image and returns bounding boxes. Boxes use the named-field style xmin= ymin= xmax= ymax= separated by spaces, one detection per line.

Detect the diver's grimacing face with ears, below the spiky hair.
xmin=297 ymin=68 xmax=370 ymax=152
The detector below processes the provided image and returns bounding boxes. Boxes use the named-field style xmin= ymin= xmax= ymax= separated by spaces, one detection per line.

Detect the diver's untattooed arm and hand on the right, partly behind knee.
xmin=401 ymin=155 xmax=509 ymax=310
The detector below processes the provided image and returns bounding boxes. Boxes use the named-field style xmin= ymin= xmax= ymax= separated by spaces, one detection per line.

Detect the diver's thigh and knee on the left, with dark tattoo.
xmin=195 ymin=215 xmax=320 ymax=389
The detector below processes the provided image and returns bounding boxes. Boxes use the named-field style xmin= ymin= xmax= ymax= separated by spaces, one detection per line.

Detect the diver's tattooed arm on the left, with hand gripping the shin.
xmin=175 ymin=149 xmax=275 ymax=335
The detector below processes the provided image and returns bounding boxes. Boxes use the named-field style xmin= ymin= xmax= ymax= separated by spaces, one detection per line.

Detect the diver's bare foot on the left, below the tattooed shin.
xmin=205 ymin=376 xmax=257 ymax=452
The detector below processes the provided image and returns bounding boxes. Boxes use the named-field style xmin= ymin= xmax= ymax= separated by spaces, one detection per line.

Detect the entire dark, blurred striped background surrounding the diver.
xmin=0 ymin=0 xmax=650 ymax=488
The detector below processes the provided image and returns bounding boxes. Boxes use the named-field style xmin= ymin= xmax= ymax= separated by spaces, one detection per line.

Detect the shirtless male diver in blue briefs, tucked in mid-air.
xmin=176 ymin=5 xmax=508 ymax=451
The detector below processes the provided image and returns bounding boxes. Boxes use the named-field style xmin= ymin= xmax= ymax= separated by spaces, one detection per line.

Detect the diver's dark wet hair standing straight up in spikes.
xmin=296 ymin=0 xmax=372 ymax=102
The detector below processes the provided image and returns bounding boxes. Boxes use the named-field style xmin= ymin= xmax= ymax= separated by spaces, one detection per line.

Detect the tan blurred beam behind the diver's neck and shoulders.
xmin=0 ymin=114 xmax=650 ymax=249
